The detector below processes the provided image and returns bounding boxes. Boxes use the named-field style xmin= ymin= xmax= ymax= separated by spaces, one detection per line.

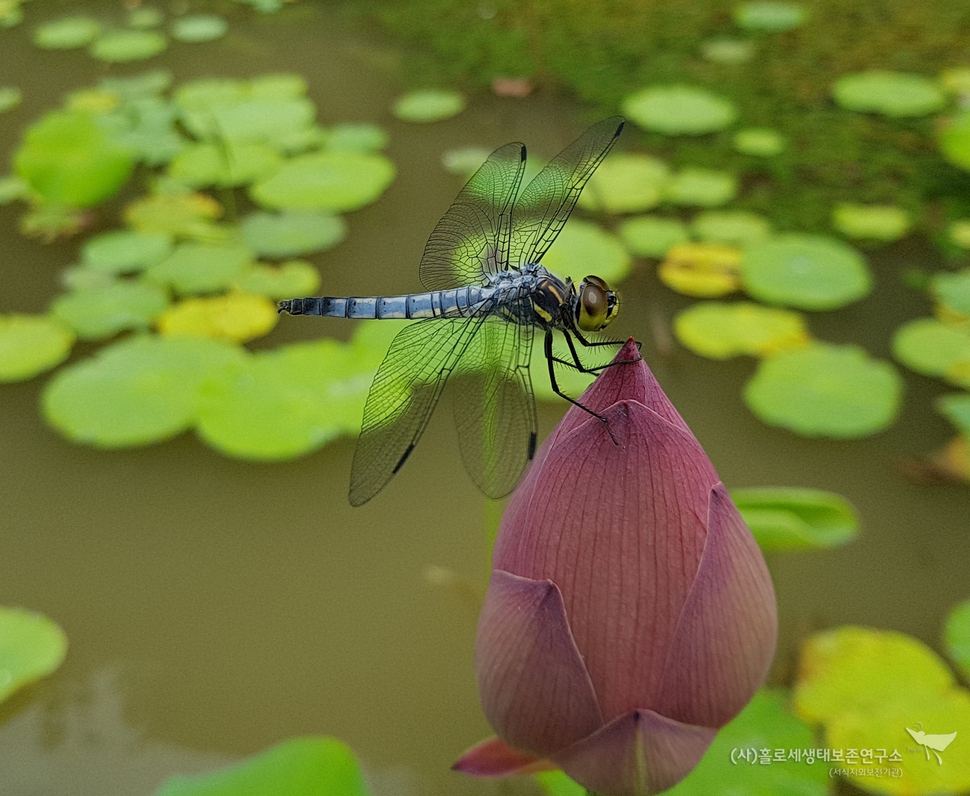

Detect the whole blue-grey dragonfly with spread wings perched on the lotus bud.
xmin=279 ymin=116 xmax=624 ymax=506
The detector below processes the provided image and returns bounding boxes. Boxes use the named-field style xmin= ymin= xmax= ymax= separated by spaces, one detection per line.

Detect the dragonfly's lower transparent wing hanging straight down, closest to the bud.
xmin=448 ymin=318 xmax=536 ymax=498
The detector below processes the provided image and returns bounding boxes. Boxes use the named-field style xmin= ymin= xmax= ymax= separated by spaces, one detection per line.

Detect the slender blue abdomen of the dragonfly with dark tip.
xmin=280 ymin=285 xmax=493 ymax=320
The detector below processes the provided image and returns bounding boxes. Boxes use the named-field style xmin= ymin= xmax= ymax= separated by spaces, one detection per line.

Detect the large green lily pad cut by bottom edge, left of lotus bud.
xmin=153 ymin=736 xmax=371 ymax=796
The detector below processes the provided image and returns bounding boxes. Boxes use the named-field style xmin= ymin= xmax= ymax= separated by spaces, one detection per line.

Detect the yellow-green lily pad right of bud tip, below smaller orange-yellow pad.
xmin=674 ymin=301 xmax=810 ymax=359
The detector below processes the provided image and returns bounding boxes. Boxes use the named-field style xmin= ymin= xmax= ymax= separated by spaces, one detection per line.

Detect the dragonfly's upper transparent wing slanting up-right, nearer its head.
xmin=510 ymin=116 xmax=624 ymax=265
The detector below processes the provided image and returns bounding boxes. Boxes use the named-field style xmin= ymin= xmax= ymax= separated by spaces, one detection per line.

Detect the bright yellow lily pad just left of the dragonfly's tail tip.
xmin=158 ymin=293 xmax=279 ymax=343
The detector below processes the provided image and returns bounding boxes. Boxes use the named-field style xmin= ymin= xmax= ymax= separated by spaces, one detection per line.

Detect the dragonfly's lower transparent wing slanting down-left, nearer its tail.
xmin=350 ymin=316 xmax=484 ymax=506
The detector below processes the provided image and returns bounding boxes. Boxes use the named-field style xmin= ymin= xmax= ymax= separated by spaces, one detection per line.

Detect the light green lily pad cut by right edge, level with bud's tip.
xmin=893 ymin=318 xmax=970 ymax=388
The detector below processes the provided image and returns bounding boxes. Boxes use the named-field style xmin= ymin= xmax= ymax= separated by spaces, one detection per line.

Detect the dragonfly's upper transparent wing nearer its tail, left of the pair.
xmin=420 ymin=144 xmax=525 ymax=290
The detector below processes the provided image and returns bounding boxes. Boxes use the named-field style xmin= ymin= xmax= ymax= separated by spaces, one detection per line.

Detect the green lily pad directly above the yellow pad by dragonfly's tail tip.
xmin=145 ymin=243 xmax=252 ymax=295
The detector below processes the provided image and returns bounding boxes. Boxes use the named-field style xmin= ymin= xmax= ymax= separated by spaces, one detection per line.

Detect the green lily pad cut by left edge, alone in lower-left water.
xmin=0 ymin=607 xmax=67 ymax=702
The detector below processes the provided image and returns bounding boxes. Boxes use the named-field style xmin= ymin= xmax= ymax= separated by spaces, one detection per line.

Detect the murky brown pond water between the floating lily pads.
xmin=0 ymin=3 xmax=970 ymax=796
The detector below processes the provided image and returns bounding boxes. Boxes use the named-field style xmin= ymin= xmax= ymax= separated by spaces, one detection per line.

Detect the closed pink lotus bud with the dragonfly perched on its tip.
xmin=455 ymin=340 xmax=778 ymax=796
